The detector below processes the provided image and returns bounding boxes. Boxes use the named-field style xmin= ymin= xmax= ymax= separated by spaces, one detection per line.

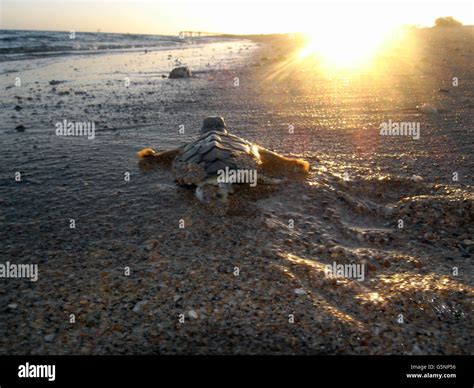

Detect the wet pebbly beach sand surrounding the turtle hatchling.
xmin=0 ymin=28 xmax=474 ymax=354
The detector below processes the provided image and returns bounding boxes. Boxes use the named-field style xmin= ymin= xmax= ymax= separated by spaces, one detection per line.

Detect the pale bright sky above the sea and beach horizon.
xmin=0 ymin=0 xmax=474 ymax=35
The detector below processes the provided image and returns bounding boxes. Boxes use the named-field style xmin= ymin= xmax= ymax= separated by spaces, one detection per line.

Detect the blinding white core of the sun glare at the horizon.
xmin=298 ymin=20 xmax=402 ymax=70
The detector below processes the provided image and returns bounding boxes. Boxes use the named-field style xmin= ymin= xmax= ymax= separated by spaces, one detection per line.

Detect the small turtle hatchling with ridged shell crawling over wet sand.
xmin=138 ymin=116 xmax=309 ymax=203
